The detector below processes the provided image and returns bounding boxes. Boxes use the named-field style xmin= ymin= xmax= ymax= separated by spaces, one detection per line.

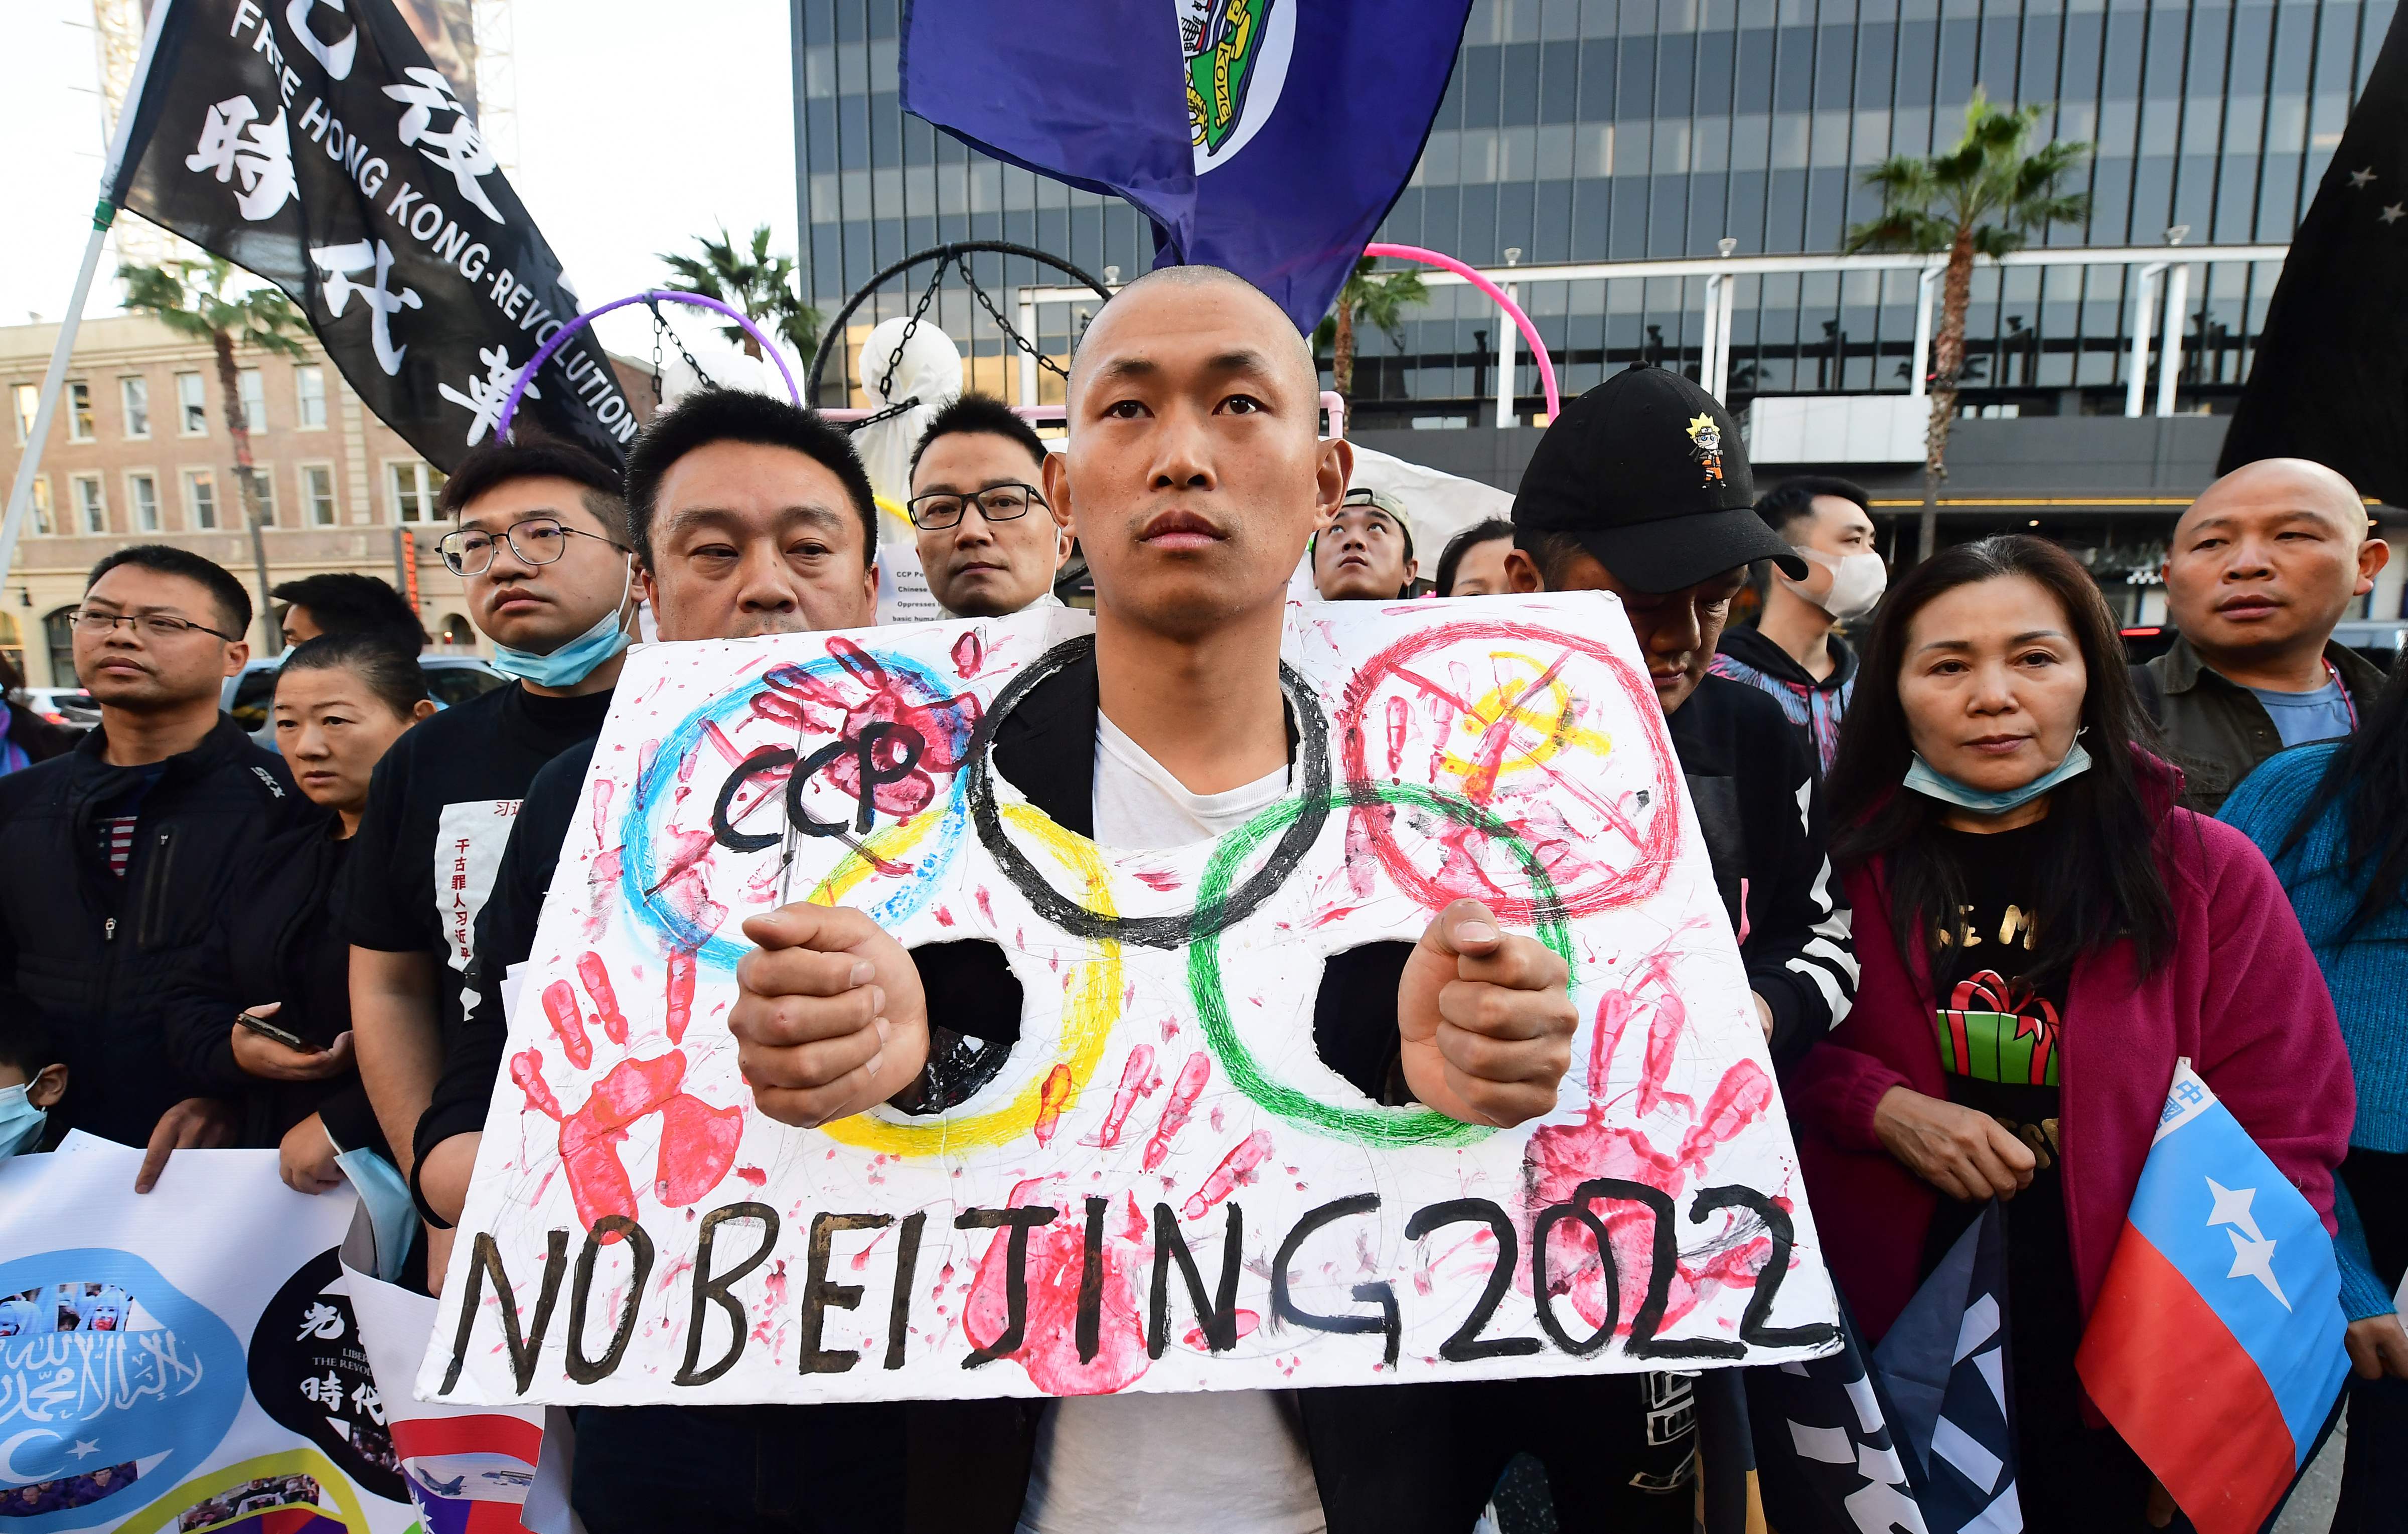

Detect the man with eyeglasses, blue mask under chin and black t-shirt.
xmin=335 ymin=443 xmax=633 ymax=1252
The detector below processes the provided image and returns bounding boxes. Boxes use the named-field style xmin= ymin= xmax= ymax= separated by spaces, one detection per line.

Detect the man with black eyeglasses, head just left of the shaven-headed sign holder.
xmin=910 ymin=395 xmax=1069 ymax=619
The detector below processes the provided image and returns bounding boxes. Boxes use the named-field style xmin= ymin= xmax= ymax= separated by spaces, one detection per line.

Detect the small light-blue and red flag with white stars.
xmin=2073 ymin=1059 xmax=2350 ymax=1534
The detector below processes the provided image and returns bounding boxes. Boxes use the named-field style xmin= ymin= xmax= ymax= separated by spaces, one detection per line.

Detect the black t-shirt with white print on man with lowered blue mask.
xmin=335 ymin=682 xmax=612 ymax=1040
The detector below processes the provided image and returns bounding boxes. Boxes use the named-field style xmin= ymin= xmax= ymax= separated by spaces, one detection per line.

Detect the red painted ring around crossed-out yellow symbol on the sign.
xmin=1336 ymin=622 xmax=1681 ymax=923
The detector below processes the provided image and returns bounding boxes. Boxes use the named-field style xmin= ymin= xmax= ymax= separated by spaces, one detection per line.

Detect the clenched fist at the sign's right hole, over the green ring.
xmin=1397 ymin=900 xmax=1580 ymax=1127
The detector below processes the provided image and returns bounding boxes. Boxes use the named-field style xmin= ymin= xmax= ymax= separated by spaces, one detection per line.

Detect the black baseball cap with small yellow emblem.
xmin=1512 ymin=366 xmax=1806 ymax=592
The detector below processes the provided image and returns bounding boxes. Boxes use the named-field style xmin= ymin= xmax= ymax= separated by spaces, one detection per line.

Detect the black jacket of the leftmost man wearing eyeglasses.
xmin=0 ymin=715 xmax=308 ymax=1146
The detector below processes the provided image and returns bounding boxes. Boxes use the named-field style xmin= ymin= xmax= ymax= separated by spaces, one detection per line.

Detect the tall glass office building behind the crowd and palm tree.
xmin=795 ymin=0 xmax=2393 ymax=424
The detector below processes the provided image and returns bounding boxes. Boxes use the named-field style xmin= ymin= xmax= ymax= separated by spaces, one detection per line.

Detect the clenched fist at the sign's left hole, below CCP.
xmin=727 ymin=903 xmax=927 ymax=1129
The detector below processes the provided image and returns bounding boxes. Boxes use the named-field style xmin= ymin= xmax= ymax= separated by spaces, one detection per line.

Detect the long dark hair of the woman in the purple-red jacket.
xmin=1828 ymin=535 xmax=2174 ymax=985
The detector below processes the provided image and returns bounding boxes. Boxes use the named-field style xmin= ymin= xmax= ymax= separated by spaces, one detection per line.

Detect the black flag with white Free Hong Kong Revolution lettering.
xmin=108 ymin=0 xmax=636 ymax=470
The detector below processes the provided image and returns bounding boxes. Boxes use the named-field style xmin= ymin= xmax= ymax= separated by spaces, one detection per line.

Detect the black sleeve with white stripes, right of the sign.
xmin=1667 ymin=677 xmax=1857 ymax=1069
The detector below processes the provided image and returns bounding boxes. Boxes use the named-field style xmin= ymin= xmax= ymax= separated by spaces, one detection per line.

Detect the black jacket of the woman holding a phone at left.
xmin=166 ymin=812 xmax=385 ymax=1154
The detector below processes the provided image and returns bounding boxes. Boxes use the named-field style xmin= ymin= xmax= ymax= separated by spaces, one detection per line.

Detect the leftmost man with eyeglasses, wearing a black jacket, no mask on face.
xmin=0 ymin=544 xmax=306 ymax=1192
